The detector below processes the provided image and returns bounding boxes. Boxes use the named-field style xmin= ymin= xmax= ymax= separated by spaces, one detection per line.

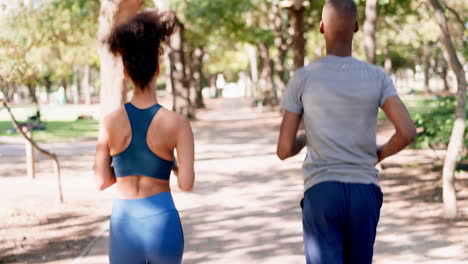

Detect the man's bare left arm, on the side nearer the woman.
xmin=276 ymin=111 xmax=307 ymax=160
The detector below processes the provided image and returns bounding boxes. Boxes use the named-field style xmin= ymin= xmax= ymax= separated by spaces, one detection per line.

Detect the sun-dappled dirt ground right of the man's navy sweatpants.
xmin=374 ymin=147 xmax=468 ymax=264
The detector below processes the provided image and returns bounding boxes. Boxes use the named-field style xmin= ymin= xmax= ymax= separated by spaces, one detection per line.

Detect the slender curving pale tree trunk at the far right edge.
xmin=430 ymin=0 xmax=466 ymax=218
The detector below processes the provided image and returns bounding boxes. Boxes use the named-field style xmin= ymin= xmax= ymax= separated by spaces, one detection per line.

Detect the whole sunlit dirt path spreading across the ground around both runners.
xmin=0 ymin=99 xmax=468 ymax=264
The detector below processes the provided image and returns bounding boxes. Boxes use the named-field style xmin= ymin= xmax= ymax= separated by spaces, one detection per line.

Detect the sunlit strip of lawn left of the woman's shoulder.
xmin=0 ymin=105 xmax=99 ymax=142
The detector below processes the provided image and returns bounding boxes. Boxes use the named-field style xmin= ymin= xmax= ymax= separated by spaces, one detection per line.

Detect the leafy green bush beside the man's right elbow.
xmin=415 ymin=96 xmax=468 ymax=151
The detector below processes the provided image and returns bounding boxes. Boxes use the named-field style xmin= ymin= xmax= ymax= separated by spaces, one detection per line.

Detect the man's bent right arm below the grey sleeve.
xmin=377 ymin=96 xmax=416 ymax=163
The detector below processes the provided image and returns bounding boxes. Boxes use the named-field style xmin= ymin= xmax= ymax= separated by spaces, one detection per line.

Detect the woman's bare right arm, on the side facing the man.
xmin=176 ymin=117 xmax=195 ymax=192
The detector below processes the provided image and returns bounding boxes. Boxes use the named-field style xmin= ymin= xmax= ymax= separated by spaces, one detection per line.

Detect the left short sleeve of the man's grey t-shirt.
xmin=281 ymin=71 xmax=304 ymax=115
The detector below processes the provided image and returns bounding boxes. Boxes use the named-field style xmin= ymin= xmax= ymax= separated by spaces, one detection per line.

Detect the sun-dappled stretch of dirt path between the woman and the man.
xmin=174 ymin=100 xmax=304 ymax=263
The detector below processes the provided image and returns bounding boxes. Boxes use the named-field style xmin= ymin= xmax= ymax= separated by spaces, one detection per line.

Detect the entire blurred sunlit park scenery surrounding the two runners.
xmin=0 ymin=0 xmax=468 ymax=264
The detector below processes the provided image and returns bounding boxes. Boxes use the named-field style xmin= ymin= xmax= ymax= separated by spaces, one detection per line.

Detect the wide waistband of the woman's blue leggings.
xmin=112 ymin=191 xmax=177 ymax=219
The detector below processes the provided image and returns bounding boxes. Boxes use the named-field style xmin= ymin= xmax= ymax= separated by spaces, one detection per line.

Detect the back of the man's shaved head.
xmin=321 ymin=0 xmax=358 ymax=40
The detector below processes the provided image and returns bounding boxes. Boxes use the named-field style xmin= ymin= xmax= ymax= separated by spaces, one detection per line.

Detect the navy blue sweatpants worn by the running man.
xmin=301 ymin=182 xmax=382 ymax=264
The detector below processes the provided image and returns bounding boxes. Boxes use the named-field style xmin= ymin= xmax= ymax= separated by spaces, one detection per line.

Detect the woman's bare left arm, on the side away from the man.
xmin=93 ymin=119 xmax=117 ymax=191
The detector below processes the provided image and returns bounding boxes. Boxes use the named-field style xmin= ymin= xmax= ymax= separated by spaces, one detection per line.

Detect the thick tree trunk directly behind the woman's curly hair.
xmin=98 ymin=0 xmax=144 ymax=115
